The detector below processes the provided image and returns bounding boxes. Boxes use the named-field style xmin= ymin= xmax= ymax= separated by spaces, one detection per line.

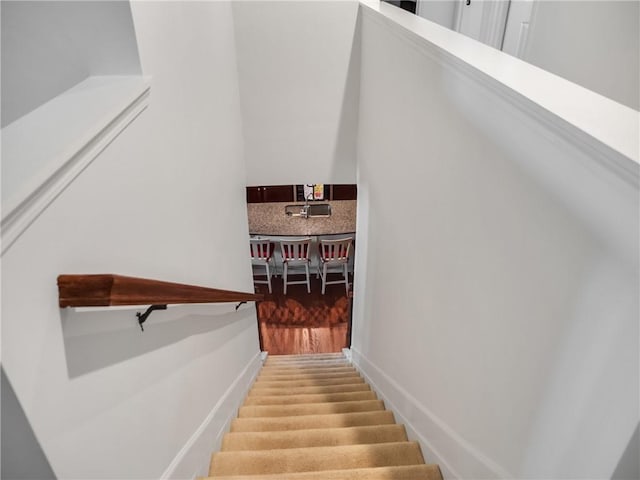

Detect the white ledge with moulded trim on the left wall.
xmin=1 ymin=77 xmax=151 ymax=254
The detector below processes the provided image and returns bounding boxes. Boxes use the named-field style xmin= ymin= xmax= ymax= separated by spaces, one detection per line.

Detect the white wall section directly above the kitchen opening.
xmin=233 ymin=0 xmax=359 ymax=185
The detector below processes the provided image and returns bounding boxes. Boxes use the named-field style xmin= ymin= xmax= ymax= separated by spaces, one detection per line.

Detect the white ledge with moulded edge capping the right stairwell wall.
xmin=361 ymin=0 xmax=640 ymax=188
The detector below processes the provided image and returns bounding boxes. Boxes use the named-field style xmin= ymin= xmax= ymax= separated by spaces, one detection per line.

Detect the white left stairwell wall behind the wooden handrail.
xmin=2 ymin=2 xmax=259 ymax=479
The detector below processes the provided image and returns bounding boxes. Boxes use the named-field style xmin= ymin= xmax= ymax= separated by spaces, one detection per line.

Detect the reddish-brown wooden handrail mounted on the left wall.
xmin=58 ymin=274 xmax=264 ymax=308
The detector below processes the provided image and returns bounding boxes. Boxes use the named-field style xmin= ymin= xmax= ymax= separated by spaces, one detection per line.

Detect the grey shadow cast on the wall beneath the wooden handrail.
xmin=61 ymin=304 xmax=255 ymax=378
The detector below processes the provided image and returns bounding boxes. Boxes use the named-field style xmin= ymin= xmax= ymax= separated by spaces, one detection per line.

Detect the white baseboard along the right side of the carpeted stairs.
xmin=351 ymin=347 xmax=515 ymax=479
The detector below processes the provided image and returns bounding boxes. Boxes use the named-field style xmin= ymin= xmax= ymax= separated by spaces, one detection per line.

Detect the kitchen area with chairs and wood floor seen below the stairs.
xmin=247 ymin=184 xmax=357 ymax=355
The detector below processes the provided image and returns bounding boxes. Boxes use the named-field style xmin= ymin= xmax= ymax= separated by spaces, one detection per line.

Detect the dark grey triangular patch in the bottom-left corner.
xmin=0 ymin=368 xmax=56 ymax=480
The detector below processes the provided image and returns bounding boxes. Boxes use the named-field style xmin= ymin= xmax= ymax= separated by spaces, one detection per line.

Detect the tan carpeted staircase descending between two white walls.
xmin=202 ymin=354 xmax=442 ymax=480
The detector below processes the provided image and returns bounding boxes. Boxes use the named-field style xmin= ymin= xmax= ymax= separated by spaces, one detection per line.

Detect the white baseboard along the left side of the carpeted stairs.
xmin=160 ymin=352 xmax=264 ymax=480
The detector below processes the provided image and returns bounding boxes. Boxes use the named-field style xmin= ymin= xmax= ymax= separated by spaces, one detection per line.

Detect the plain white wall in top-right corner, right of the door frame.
xmin=523 ymin=0 xmax=640 ymax=110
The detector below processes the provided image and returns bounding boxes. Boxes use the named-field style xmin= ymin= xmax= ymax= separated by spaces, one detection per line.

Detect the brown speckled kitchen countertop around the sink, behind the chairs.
xmin=247 ymin=200 xmax=356 ymax=236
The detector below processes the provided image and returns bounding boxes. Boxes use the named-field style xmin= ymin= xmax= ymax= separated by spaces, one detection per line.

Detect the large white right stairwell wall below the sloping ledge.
xmin=352 ymin=2 xmax=640 ymax=479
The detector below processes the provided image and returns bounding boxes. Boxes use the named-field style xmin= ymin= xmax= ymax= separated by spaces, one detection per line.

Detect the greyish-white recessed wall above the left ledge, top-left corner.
xmin=1 ymin=0 xmax=140 ymax=127
